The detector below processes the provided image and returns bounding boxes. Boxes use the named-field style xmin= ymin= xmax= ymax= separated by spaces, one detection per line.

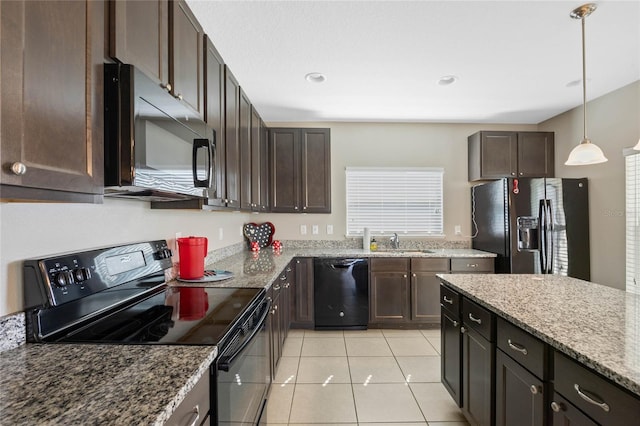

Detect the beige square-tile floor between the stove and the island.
xmin=267 ymin=330 xmax=468 ymax=426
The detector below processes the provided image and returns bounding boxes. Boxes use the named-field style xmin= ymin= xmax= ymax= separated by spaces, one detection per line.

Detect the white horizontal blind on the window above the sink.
xmin=346 ymin=167 xmax=444 ymax=236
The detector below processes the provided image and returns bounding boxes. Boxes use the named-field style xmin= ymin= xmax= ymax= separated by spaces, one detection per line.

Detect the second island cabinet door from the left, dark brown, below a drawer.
xmin=461 ymin=324 xmax=496 ymax=426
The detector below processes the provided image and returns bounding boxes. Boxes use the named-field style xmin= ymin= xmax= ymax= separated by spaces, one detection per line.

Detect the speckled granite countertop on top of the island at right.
xmin=438 ymin=274 xmax=640 ymax=396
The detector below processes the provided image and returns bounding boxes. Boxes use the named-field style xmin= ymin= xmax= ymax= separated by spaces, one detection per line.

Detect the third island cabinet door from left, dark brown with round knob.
xmin=495 ymin=349 xmax=545 ymax=426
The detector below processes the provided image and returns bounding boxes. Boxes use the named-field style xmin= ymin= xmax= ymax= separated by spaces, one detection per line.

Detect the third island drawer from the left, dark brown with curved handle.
xmin=496 ymin=318 xmax=548 ymax=380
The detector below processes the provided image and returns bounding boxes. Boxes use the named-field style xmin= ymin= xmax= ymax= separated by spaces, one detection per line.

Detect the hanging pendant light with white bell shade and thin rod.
xmin=564 ymin=3 xmax=607 ymax=166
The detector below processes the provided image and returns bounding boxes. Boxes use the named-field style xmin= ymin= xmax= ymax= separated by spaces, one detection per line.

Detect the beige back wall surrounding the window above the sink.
xmin=260 ymin=122 xmax=537 ymax=240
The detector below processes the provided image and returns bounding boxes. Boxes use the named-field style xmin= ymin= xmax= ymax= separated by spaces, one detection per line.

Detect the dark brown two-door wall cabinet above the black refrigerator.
xmin=468 ymin=131 xmax=555 ymax=181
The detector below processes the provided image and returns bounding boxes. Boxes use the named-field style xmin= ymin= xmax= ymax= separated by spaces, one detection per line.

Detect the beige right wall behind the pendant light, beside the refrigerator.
xmin=539 ymin=81 xmax=640 ymax=289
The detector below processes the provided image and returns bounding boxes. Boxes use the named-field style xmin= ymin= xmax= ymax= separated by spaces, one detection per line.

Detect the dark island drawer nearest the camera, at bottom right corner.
xmin=554 ymin=352 xmax=640 ymax=426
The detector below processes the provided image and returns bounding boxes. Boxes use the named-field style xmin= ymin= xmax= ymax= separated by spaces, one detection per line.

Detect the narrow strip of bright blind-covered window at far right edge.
xmin=625 ymin=151 xmax=640 ymax=294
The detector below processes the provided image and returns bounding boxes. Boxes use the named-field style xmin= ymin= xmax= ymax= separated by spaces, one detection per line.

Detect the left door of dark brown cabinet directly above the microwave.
xmin=109 ymin=0 xmax=170 ymax=88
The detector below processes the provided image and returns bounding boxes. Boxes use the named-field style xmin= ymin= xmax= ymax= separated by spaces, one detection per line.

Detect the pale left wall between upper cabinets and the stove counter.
xmin=0 ymin=199 xmax=249 ymax=316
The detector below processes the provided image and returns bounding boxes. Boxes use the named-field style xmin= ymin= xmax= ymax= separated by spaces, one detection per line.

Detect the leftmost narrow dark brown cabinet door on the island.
xmin=440 ymin=309 xmax=462 ymax=406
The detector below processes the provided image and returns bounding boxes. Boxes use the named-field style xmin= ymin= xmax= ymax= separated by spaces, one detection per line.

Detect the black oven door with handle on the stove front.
xmin=211 ymin=300 xmax=271 ymax=426
